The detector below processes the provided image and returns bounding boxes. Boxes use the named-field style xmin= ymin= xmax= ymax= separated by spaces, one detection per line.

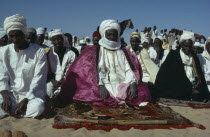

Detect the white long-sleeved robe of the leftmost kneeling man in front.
xmin=0 ymin=44 xmax=47 ymax=117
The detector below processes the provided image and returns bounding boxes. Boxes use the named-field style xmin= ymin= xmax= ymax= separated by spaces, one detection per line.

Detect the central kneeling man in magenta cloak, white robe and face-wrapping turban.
xmin=59 ymin=20 xmax=151 ymax=107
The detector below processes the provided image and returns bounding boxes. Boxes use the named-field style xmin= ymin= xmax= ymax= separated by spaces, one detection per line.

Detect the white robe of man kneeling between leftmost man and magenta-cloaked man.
xmin=47 ymin=47 xmax=76 ymax=97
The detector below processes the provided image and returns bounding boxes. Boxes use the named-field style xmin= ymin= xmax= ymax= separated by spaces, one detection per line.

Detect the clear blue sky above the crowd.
xmin=0 ymin=0 xmax=210 ymax=43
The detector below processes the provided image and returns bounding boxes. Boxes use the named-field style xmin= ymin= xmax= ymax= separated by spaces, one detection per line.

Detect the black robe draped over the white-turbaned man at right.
xmin=152 ymin=50 xmax=210 ymax=101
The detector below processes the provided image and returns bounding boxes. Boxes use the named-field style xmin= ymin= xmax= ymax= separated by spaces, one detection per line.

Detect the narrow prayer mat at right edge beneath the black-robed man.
xmin=159 ymin=98 xmax=210 ymax=109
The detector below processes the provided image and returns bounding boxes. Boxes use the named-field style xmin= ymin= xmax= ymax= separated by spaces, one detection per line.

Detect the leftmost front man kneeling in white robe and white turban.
xmin=0 ymin=14 xmax=47 ymax=118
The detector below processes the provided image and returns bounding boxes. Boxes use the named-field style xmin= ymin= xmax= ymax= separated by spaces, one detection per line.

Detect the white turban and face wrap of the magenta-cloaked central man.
xmin=99 ymin=19 xmax=121 ymax=50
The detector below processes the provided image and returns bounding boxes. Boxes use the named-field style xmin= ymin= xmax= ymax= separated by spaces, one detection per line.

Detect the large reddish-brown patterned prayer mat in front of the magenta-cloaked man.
xmin=53 ymin=103 xmax=205 ymax=131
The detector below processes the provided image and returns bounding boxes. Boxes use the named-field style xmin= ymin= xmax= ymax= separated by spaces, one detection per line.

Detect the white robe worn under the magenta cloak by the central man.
xmin=98 ymin=46 xmax=137 ymax=99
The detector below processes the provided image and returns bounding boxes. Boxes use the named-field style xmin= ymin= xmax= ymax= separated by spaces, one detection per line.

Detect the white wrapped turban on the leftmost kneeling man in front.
xmin=4 ymin=14 xmax=27 ymax=35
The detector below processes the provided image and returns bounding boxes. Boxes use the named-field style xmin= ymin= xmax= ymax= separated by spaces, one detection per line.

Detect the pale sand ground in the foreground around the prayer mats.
xmin=0 ymin=106 xmax=210 ymax=137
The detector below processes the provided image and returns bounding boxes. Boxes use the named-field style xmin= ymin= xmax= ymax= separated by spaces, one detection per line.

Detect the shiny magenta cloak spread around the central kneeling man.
xmin=60 ymin=46 xmax=151 ymax=107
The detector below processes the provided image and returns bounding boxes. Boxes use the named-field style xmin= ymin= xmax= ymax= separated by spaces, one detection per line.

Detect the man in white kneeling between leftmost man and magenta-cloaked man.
xmin=47 ymin=29 xmax=76 ymax=98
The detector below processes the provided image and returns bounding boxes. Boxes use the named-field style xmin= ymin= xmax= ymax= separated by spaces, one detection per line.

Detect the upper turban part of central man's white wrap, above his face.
xmin=99 ymin=19 xmax=121 ymax=37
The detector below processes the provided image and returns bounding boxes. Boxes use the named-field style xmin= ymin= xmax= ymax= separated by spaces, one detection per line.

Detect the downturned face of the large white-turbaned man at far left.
xmin=9 ymin=30 xmax=25 ymax=45
